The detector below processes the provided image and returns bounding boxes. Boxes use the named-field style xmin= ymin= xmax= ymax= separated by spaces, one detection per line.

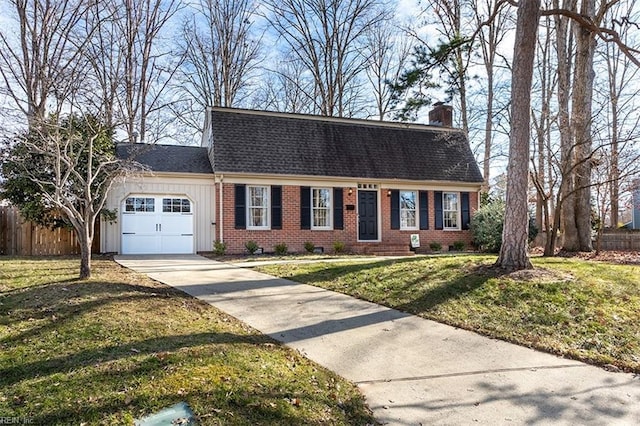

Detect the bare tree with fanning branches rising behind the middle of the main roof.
xmin=265 ymin=0 xmax=389 ymax=117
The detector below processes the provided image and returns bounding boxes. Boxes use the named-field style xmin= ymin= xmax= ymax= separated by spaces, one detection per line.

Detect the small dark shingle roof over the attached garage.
xmin=116 ymin=144 xmax=213 ymax=173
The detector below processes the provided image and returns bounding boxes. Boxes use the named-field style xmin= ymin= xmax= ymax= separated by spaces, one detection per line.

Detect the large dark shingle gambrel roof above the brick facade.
xmin=209 ymin=108 xmax=482 ymax=183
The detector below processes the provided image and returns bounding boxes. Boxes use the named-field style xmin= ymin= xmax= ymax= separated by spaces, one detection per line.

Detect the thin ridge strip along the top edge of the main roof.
xmin=207 ymin=107 xmax=462 ymax=133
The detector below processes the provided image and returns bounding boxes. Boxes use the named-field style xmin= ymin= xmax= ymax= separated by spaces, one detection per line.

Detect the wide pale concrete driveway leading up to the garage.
xmin=116 ymin=256 xmax=640 ymax=425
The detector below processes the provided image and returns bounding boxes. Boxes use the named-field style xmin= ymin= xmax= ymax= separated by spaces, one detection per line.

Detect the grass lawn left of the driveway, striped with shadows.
xmin=0 ymin=257 xmax=374 ymax=425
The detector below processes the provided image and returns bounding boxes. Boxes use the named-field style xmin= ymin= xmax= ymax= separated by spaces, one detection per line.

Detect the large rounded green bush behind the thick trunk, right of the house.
xmin=471 ymin=200 xmax=538 ymax=253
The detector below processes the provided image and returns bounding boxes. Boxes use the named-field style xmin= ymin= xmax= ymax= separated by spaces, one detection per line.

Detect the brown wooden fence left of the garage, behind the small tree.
xmin=0 ymin=206 xmax=100 ymax=256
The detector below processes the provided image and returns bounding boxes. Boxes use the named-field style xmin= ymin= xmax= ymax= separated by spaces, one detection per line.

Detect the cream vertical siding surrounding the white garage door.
xmin=100 ymin=173 xmax=216 ymax=253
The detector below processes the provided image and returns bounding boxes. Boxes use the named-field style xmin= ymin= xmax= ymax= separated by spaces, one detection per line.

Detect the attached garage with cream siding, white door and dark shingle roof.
xmin=100 ymin=144 xmax=216 ymax=254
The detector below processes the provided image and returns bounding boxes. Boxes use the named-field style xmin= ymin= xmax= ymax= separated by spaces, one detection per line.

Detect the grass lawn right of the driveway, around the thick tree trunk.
xmin=257 ymin=255 xmax=640 ymax=373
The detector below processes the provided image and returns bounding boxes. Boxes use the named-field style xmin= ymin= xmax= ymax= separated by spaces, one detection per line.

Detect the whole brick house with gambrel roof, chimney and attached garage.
xmin=102 ymin=105 xmax=482 ymax=254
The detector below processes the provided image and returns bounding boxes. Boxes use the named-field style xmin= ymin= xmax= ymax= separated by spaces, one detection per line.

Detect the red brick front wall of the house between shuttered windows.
xmin=216 ymin=183 xmax=478 ymax=254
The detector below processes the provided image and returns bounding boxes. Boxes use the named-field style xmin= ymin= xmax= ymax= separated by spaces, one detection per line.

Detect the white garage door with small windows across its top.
xmin=121 ymin=195 xmax=194 ymax=254
